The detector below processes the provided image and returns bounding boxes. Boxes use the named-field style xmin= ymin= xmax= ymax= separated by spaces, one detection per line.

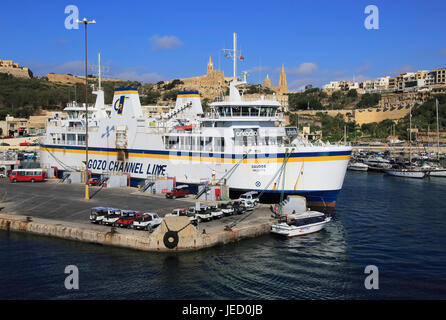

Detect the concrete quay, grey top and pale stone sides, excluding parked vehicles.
xmin=0 ymin=179 xmax=277 ymax=252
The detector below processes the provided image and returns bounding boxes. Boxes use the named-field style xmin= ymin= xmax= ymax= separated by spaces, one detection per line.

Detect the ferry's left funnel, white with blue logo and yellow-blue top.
xmin=111 ymin=88 xmax=143 ymax=121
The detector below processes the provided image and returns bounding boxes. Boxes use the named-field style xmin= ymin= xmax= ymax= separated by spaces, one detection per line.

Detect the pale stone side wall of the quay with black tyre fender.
xmin=0 ymin=208 xmax=277 ymax=252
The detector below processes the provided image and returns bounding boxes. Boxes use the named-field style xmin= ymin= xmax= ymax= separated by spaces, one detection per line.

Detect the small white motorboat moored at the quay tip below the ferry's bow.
xmin=271 ymin=211 xmax=331 ymax=238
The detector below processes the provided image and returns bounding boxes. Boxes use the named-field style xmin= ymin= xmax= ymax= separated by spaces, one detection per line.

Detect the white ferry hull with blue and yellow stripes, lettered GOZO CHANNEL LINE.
xmin=40 ymin=141 xmax=351 ymax=206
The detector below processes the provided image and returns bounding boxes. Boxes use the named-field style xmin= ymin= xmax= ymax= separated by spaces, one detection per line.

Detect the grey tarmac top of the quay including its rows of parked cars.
xmin=0 ymin=180 xmax=271 ymax=244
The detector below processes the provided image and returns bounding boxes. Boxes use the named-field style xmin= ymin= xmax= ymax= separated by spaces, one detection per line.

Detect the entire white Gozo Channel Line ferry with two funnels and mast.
xmin=40 ymin=34 xmax=352 ymax=207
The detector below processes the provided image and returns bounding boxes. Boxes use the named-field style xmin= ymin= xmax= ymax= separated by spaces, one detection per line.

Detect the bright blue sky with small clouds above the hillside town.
xmin=0 ymin=0 xmax=446 ymax=91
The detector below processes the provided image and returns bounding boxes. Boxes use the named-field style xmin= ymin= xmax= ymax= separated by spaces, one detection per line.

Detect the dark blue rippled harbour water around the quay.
xmin=0 ymin=172 xmax=446 ymax=299
